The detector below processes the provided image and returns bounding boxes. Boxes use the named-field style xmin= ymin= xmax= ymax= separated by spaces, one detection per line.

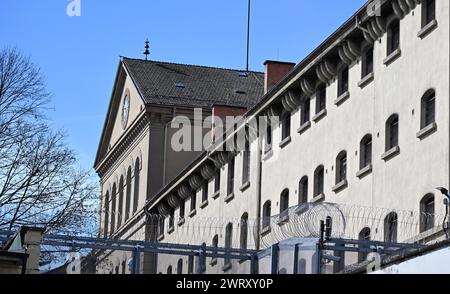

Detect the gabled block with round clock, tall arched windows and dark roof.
xmin=95 ymin=58 xmax=264 ymax=272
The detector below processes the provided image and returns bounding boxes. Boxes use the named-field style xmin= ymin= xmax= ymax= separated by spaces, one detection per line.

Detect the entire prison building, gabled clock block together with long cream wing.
xmin=96 ymin=0 xmax=450 ymax=274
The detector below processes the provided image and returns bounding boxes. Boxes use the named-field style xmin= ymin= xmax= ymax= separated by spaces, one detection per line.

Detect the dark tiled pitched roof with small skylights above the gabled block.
xmin=123 ymin=58 xmax=264 ymax=108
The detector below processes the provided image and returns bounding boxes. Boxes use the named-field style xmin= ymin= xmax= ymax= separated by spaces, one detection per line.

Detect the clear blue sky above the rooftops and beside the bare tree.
xmin=0 ymin=0 xmax=366 ymax=172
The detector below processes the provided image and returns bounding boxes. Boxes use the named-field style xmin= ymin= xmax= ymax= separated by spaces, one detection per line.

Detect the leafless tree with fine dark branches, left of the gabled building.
xmin=0 ymin=48 xmax=97 ymax=234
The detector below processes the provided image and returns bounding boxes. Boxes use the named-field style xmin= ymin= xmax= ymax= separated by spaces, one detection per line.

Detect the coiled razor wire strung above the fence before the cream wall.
xmin=148 ymin=202 xmax=445 ymax=248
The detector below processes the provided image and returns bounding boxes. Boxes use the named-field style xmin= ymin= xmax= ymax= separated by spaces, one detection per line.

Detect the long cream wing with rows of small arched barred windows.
xmin=97 ymin=0 xmax=450 ymax=274
